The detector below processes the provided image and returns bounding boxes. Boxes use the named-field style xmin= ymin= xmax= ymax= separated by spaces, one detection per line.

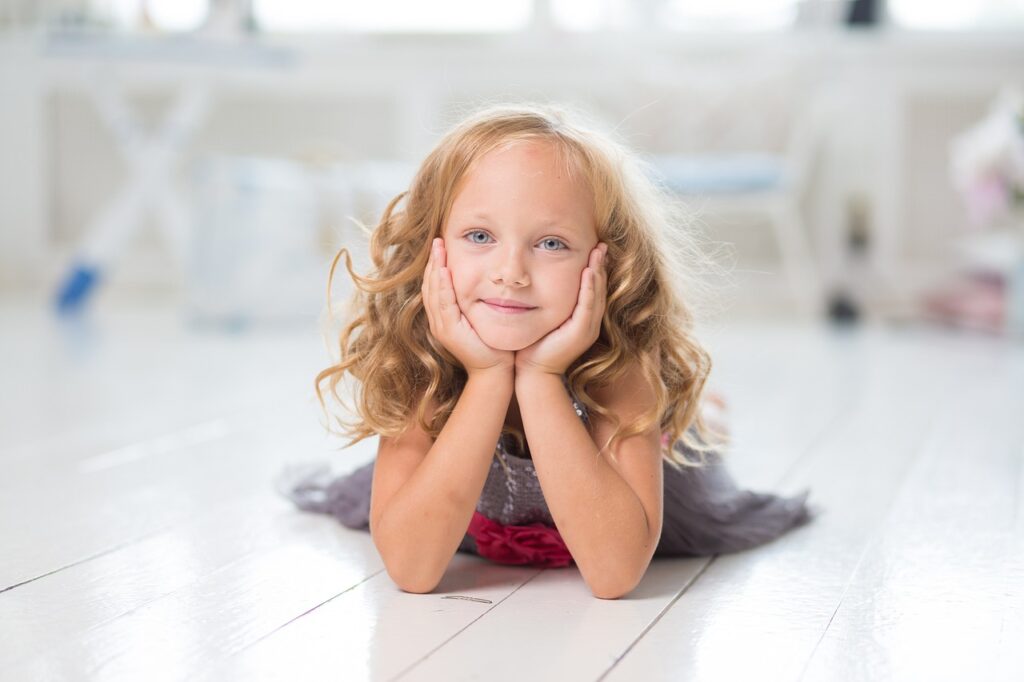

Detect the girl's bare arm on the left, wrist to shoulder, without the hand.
xmin=370 ymin=368 xmax=514 ymax=593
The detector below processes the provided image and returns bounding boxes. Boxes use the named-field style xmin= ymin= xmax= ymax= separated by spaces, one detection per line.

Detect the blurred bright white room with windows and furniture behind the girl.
xmin=0 ymin=0 xmax=1024 ymax=334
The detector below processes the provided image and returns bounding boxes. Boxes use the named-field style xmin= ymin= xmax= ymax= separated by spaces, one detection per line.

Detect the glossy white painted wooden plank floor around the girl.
xmin=0 ymin=288 xmax=1024 ymax=682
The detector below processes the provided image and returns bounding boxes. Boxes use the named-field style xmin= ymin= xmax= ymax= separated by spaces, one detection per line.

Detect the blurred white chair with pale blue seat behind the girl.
xmin=598 ymin=69 xmax=829 ymax=314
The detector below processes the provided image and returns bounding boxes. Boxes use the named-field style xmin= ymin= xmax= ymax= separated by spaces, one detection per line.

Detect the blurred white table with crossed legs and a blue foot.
xmin=42 ymin=32 xmax=291 ymax=312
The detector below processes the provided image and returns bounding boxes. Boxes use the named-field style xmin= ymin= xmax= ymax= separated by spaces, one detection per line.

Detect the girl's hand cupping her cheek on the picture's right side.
xmin=515 ymin=243 xmax=608 ymax=376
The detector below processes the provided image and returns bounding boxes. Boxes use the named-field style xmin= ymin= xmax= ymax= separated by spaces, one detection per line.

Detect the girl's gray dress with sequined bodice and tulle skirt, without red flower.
xmin=276 ymin=378 xmax=816 ymax=556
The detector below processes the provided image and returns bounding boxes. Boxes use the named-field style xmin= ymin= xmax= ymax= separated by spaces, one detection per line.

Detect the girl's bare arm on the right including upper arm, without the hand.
xmin=515 ymin=358 xmax=665 ymax=599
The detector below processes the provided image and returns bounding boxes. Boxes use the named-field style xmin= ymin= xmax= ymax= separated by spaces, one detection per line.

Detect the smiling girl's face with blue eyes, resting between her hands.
xmin=441 ymin=141 xmax=597 ymax=350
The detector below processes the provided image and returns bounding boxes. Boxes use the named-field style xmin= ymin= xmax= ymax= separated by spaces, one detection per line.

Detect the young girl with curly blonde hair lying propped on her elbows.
xmin=283 ymin=106 xmax=812 ymax=599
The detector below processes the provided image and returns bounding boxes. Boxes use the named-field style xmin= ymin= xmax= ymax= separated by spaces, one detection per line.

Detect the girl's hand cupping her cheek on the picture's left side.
xmin=420 ymin=239 xmax=515 ymax=374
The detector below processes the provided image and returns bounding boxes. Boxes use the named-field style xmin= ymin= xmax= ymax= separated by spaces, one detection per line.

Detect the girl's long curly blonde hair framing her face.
xmin=314 ymin=104 xmax=728 ymax=467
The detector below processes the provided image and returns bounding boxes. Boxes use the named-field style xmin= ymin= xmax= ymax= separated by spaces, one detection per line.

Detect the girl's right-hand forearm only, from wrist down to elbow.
xmin=515 ymin=373 xmax=652 ymax=598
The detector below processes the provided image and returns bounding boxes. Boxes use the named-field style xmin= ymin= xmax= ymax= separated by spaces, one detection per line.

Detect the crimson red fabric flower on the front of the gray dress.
xmin=469 ymin=511 xmax=572 ymax=568
